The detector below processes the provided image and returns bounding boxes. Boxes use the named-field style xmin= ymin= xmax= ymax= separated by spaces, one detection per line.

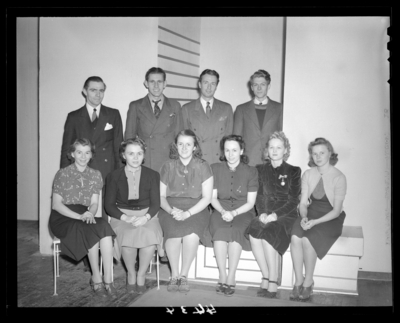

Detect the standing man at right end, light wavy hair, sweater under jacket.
xmin=233 ymin=70 xmax=283 ymax=166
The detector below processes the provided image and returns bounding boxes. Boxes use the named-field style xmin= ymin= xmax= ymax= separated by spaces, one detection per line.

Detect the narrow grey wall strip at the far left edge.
xmin=17 ymin=18 xmax=39 ymax=221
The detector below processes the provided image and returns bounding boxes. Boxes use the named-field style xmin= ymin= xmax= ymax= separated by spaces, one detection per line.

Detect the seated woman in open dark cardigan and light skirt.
xmin=104 ymin=137 xmax=164 ymax=294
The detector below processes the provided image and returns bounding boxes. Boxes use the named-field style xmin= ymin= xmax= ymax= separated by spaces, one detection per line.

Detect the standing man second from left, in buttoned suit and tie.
xmin=125 ymin=67 xmax=183 ymax=172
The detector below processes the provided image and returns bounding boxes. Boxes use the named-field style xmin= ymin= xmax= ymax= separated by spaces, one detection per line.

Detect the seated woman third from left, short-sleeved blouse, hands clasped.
xmin=159 ymin=130 xmax=213 ymax=292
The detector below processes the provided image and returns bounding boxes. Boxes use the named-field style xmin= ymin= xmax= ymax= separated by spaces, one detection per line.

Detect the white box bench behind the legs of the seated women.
xmin=188 ymin=226 xmax=364 ymax=295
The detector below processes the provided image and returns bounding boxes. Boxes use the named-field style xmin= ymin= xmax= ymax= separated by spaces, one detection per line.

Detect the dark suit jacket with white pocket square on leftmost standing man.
xmin=60 ymin=105 xmax=123 ymax=183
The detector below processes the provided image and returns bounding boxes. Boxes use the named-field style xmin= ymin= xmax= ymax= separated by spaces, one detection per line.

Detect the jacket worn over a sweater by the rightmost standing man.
xmin=233 ymin=98 xmax=283 ymax=166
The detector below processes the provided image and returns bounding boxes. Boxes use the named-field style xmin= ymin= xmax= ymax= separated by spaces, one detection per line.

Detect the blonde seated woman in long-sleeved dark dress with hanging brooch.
xmin=246 ymin=131 xmax=301 ymax=298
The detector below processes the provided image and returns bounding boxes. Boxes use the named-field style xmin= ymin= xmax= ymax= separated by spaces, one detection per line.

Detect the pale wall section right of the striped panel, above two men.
xmin=200 ymin=17 xmax=284 ymax=110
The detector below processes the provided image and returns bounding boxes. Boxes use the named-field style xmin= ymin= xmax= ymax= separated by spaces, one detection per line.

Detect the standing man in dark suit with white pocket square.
xmin=60 ymin=76 xmax=123 ymax=271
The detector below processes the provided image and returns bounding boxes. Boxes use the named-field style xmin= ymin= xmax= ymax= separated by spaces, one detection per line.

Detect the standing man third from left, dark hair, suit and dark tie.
xmin=182 ymin=69 xmax=233 ymax=165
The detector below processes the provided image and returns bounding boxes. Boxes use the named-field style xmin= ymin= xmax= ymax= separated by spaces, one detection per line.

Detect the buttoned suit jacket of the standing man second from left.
xmin=125 ymin=95 xmax=183 ymax=172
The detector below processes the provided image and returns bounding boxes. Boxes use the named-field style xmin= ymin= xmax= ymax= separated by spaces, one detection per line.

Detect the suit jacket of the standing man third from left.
xmin=182 ymin=98 xmax=233 ymax=165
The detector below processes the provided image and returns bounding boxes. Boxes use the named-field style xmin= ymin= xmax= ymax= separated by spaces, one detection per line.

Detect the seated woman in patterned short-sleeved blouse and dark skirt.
xmin=49 ymin=138 xmax=115 ymax=296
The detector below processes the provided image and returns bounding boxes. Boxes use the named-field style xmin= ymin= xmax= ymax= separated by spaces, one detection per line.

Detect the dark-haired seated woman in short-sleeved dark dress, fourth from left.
xmin=210 ymin=135 xmax=258 ymax=296
